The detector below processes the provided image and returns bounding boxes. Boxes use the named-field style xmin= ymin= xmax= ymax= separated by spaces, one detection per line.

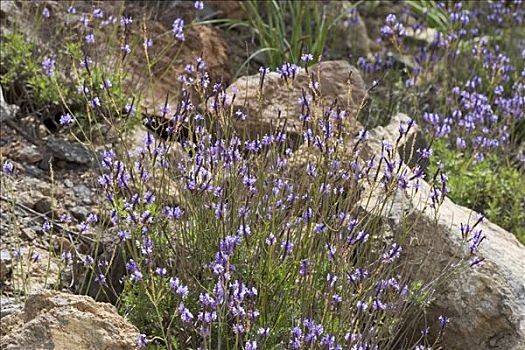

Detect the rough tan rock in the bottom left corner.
xmin=0 ymin=291 xmax=139 ymax=350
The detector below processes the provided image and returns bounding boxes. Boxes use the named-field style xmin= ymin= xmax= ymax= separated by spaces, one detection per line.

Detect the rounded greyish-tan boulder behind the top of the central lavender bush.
xmin=226 ymin=61 xmax=367 ymax=148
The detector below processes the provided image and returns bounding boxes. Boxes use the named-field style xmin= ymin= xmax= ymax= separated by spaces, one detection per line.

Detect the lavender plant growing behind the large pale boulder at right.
xmin=357 ymin=1 xmax=525 ymax=241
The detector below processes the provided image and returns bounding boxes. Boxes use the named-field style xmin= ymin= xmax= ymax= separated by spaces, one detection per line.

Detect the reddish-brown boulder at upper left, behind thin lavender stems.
xmin=126 ymin=8 xmax=231 ymax=116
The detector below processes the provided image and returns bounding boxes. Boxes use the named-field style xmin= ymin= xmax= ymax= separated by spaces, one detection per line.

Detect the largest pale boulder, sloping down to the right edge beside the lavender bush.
xmin=361 ymin=115 xmax=525 ymax=350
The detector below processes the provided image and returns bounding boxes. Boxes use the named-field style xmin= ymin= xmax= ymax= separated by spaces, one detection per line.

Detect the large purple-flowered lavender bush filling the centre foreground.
xmin=2 ymin=3 xmax=521 ymax=350
